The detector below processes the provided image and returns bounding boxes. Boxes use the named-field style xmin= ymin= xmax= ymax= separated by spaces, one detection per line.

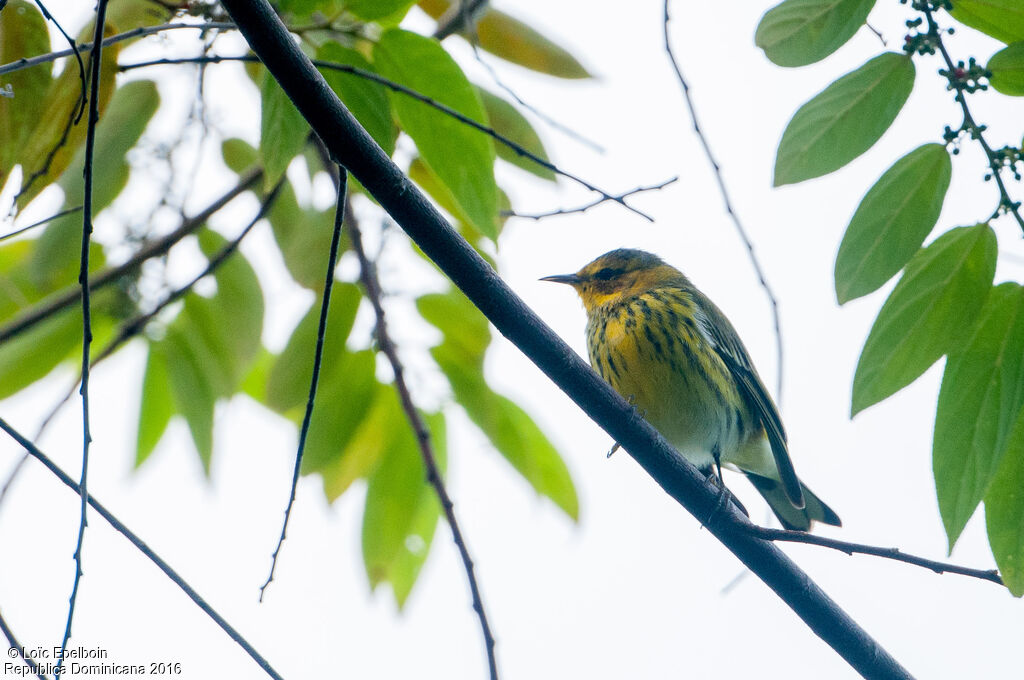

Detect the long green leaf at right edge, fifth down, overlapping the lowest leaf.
xmin=932 ymin=283 xmax=1024 ymax=552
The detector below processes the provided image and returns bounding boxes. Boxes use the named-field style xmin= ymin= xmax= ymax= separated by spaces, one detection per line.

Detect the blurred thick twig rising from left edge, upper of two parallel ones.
xmin=0 ymin=168 xmax=263 ymax=344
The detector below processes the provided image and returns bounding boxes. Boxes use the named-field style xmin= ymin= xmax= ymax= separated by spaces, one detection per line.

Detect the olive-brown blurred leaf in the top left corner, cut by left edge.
xmin=0 ymin=0 xmax=53 ymax=188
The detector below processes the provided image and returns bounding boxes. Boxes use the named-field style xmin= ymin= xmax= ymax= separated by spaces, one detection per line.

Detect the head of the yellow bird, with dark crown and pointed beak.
xmin=541 ymin=248 xmax=686 ymax=313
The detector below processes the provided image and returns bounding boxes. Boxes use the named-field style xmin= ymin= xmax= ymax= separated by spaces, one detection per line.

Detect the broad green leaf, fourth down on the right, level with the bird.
xmin=851 ymin=224 xmax=996 ymax=417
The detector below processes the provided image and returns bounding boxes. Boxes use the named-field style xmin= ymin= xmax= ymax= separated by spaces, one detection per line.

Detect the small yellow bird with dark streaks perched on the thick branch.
xmin=541 ymin=248 xmax=841 ymax=532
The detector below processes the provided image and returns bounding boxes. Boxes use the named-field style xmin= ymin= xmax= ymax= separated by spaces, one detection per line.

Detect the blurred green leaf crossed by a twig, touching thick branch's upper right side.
xmin=316 ymin=41 xmax=397 ymax=156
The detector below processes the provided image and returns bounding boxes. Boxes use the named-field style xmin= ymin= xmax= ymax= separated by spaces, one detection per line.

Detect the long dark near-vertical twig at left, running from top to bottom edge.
xmin=54 ymin=0 xmax=108 ymax=677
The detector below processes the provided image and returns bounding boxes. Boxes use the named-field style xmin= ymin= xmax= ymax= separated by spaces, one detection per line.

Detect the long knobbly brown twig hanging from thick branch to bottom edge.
xmin=346 ymin=178 xmax=498 ymax=680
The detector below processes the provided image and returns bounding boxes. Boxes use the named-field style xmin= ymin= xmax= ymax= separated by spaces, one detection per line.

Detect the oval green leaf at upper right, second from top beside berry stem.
xmin=774 ymin=52 xmax=914 ymax=186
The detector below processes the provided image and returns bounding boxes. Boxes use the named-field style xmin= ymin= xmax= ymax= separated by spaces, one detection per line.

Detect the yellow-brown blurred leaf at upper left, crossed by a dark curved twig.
xmin=17 ymin=26 xmax=121 ymax=207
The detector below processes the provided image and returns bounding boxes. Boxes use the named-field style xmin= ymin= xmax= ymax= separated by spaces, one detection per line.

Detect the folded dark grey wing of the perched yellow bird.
xmin=694 ymin=291 xmax=804 ymax=508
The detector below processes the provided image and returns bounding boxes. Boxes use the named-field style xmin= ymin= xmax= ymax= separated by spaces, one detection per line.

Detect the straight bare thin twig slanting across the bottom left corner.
xmin=0 ymin=418 xmax=284 ymax=680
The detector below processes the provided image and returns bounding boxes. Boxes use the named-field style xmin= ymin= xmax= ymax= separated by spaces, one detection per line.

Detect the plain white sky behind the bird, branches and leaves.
xmin=0 ymin=0 xmax=1024 ymax=680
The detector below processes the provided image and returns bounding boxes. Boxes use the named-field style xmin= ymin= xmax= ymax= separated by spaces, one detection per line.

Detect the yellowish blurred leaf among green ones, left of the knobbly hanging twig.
xmin=319 ymin=383 xmax=406 ymax=503
